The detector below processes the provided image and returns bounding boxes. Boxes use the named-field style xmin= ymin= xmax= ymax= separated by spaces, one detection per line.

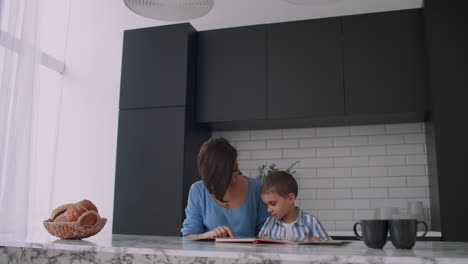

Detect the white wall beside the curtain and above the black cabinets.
xmin=53 ymin=0 xmax=422 ymax=235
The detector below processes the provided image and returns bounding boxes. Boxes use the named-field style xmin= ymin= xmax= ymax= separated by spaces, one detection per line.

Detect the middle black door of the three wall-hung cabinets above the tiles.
xmin=267 ymin=18 xmax=344 ymax=119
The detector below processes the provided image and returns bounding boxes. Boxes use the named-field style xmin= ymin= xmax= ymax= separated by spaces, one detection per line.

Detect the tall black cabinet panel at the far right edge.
xmin=423 ymin=0 xmax=468 ymax=241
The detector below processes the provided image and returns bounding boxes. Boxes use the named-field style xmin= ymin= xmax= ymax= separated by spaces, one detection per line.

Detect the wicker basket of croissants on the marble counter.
xmin=44 ymin=200 xmax=107 ymax=239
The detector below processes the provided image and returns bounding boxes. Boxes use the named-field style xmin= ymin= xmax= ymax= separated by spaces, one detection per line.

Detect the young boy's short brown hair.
xmin=260 ymin=171 xmax=297 ymax=197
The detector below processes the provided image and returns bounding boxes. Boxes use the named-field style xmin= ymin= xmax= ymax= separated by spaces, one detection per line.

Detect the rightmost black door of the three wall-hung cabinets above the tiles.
xmin=342 ymin=9 xmax=427 ymax=115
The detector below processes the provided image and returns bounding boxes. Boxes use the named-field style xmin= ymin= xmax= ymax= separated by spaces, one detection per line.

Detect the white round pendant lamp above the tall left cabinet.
xmin=123 ymin=0 xmax=214 ymax=21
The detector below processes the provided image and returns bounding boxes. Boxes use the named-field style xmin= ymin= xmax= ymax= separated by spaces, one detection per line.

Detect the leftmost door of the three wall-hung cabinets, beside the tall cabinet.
xmin=197 ymin=25 xmax=266 ymax=122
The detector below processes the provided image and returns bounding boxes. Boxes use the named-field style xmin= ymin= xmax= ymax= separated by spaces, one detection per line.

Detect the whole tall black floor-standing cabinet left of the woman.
xmin=112 ymin=24 xmax=211 ymax=236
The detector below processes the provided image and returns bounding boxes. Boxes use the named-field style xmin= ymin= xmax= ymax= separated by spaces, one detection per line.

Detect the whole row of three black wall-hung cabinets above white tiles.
xmin=197 ymin=9 xmax=428 ymax=129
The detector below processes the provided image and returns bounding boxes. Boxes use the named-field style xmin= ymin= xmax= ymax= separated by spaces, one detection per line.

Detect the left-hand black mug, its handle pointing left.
xmin=353 ymin=220 xmax=388 ymax=248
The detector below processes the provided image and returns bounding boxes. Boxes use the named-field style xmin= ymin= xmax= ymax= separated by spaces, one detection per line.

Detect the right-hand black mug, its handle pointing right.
xmin=388 ymin=219 xmax=428 ymax=249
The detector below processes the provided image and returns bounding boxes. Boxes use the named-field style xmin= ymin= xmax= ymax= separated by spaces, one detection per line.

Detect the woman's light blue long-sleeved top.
xmin=182 ymin=178 xmax=270 ymax=237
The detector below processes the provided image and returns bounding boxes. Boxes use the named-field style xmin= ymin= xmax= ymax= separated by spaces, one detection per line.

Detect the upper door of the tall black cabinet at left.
xmin=120 ymin=23 xmax=194 ymax=109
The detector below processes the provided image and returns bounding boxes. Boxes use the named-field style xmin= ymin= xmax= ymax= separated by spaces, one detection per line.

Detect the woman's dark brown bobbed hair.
xmin=197 ymin=138 xmax=237 ymax=202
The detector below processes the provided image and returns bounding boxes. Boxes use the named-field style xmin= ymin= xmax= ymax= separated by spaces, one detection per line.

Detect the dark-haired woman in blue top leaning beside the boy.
xmin=183 ymin=138 xmax=269 ymax=239
